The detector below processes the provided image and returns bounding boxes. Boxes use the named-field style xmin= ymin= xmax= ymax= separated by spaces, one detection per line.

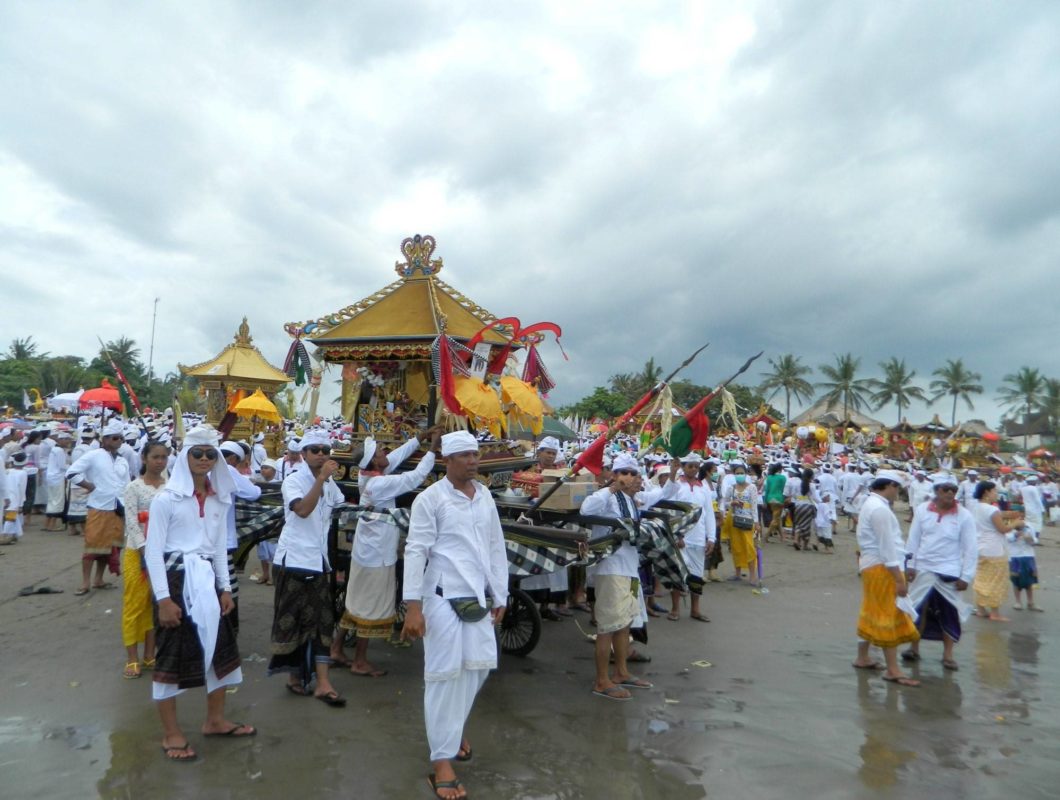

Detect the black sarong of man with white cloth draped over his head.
xmin=152 ymin=554 xmax=240 ymax=689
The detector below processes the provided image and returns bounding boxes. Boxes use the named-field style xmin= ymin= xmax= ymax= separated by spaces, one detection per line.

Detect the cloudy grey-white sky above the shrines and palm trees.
xmin=0 ymin=0 xmax=1060 ymax=422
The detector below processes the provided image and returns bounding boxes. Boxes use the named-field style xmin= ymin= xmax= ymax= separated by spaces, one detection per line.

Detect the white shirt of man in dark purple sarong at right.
xmin=905 ymin=501 xmax=979 ymax=584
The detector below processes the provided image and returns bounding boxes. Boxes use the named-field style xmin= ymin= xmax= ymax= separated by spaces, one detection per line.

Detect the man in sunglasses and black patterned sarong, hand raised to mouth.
xmin=268 ymin=429 xmax=346 ymax=708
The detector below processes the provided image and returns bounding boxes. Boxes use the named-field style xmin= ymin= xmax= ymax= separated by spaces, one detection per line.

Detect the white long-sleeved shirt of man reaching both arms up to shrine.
xmin=352 ymin=439 xmax=435 ymax=567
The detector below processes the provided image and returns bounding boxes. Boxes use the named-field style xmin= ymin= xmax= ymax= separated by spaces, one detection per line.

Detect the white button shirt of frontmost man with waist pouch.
xmin=402 ymin=477 xmax=508 ymax=606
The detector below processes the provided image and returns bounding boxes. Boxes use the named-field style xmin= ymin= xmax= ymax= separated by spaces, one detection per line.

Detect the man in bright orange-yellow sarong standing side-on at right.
xmin=853 ymin=477 xmax=920 ymax=687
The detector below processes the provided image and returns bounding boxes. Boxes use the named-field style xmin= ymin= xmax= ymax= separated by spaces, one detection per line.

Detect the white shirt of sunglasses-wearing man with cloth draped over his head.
xmin=144 ymin=491 xmax=232 ymax=600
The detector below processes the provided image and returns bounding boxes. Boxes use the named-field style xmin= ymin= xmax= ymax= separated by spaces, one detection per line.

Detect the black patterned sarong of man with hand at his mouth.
xmin=268 ymin=564 xmax=335 ymax=687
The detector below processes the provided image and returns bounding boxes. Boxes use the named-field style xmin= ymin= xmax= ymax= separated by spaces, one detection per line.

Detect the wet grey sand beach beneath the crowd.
xmin=0 ymin=508 xmax=1060 ymax=800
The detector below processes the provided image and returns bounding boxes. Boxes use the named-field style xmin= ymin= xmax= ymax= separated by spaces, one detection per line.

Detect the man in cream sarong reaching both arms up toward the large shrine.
xmin=332 ymin=427 xmax=442 ymax=678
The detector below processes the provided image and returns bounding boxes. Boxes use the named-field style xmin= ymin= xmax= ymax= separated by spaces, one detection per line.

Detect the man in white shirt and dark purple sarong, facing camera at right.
xmin=902 ymin=474 xmax=978 ymax=671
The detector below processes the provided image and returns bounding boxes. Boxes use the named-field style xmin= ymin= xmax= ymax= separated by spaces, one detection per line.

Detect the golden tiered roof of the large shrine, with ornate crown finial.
xmin=284 ymin=234 xmax=508 ymax=360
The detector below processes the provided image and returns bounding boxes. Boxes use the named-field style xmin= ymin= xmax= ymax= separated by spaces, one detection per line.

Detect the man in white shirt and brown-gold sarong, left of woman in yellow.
xmin=66 ymin=420 xmax=129 ymax=595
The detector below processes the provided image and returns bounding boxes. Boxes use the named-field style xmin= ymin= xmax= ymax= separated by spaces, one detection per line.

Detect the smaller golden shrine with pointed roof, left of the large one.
xmin=177 ymin=317 xmax=290 ymax=439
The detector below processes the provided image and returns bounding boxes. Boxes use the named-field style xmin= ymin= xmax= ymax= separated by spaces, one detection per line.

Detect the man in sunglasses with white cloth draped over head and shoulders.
xmin=144 ymin=426 xmax=258 ymax=761
